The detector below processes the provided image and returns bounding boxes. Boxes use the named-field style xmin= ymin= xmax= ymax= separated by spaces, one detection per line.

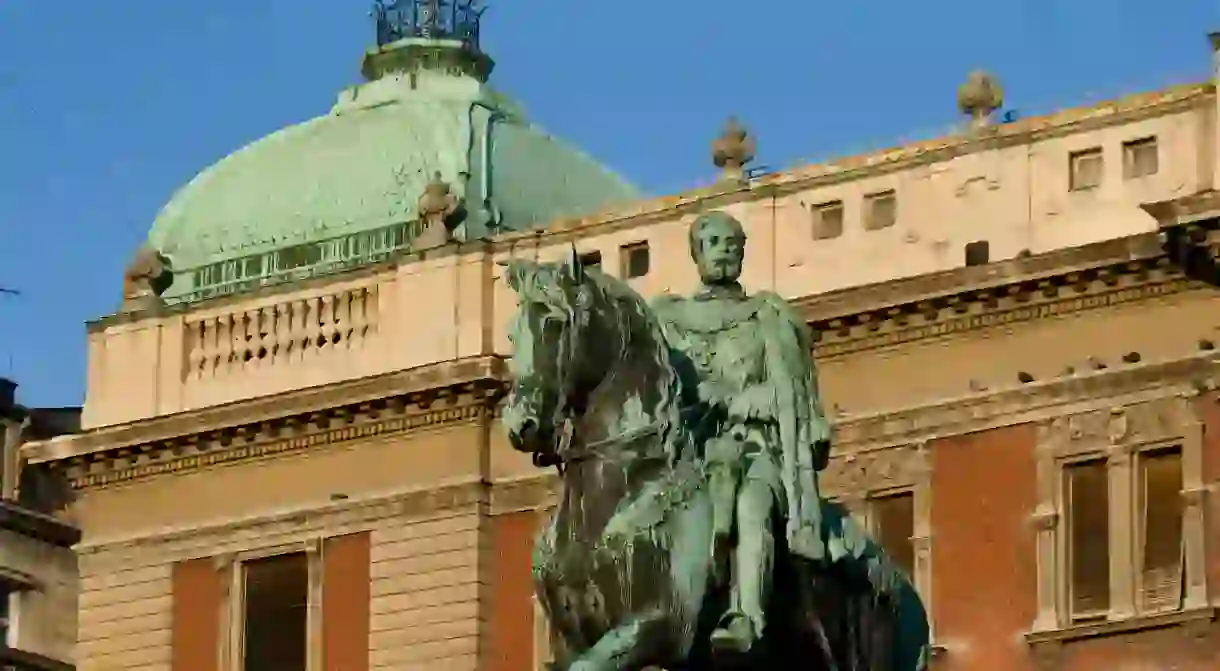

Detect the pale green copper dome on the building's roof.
xmin=149 ymin=34 xmax=639 ymax=303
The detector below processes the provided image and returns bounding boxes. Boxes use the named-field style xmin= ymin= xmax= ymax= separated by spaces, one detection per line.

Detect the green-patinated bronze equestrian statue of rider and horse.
xmin=503 ymin=212 xmax=928 ymax=671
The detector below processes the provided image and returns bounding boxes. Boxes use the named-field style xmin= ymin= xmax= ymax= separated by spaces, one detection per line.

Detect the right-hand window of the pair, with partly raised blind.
xmin=1136 ymin=448 xmax=1185 ymax=614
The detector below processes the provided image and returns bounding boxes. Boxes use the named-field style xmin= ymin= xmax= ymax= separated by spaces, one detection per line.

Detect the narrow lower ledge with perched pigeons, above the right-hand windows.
xmin=834 ymin=353 xmax=1220 ymax=455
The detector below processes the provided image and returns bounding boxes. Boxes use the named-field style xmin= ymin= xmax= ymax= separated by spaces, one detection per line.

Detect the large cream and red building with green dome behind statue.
xmin=14 ymin=2 xmax=1220 ymax=671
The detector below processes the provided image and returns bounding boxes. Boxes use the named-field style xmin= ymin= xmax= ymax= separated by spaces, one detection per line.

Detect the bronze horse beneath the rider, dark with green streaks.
xmin=501 ymin=250 xmax=928 ymax=671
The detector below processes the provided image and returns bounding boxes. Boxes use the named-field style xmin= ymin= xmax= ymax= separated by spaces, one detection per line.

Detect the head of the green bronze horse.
xmin=503 ymin=250 xmax=622 ymax=466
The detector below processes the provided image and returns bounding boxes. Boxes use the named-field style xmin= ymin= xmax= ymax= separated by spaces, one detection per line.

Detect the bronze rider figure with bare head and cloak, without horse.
xmin=655 ymin=212 xmax=830 ymax=653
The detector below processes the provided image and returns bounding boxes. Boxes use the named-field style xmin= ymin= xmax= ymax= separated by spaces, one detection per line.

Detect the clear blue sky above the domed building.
xmin=0 ymin=0 xmax=1220 ymax=405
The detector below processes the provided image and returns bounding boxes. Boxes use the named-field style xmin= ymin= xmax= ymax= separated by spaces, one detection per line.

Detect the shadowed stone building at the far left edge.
xmin=0 ymin=377 xmax=81 ymax=671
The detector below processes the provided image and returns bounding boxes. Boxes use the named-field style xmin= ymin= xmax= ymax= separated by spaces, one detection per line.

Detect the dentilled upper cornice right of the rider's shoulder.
xmin=795 ymin=233 xmax=1202 ymax=359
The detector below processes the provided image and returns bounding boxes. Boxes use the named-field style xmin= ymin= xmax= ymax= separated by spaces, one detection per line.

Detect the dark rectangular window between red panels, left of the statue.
xmin=242 ymin=553 xmax=309 ymax=671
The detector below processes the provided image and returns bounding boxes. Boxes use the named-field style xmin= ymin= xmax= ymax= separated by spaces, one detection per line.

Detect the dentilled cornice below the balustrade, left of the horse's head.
xmin=22 ymin=356 xmax=505 ymax=488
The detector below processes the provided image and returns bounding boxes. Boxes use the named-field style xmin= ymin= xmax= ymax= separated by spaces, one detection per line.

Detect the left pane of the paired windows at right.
xmin=1064 ymin=459 xmax=1110 ymax=622
